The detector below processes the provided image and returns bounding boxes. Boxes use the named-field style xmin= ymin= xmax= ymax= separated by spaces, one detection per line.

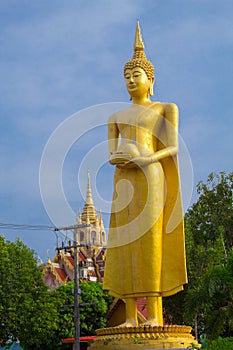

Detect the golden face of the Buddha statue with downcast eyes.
xmin=124 ymin=67 xmax=153 ymax=97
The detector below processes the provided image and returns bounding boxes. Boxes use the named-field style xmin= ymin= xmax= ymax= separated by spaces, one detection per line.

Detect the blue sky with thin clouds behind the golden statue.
xmin=0 ymin=0 xmax=233 ymax=259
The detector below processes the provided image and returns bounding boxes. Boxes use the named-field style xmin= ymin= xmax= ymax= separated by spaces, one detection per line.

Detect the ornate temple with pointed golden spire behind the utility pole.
xmin=41 ymin=172 xmax=107 ymax=289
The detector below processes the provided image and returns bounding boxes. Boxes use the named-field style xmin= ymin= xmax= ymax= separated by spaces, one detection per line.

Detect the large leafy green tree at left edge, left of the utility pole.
xmin=0 ymin=236 xmax=60 ymax=350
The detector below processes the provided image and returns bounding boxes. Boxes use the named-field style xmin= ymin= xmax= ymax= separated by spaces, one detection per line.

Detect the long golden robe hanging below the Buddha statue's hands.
xmin=104 ymin=104 xmax=187 ymax=299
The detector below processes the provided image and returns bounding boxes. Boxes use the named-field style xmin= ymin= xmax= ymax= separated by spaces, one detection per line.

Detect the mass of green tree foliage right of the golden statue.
xmin=165 ymin=172 xmax=233 ymax=339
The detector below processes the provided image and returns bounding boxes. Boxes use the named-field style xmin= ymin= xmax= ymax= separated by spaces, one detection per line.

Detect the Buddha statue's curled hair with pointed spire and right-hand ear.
xmin=124 ymin=22 xmax=154 ymax=96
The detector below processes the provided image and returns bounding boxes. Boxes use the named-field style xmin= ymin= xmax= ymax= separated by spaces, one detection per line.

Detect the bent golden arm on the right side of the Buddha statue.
xmin=150 ymin=103 xmax=179 ymax=163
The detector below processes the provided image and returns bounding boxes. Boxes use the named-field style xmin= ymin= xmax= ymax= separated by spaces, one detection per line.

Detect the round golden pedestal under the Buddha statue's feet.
xmin=89 ymin=325 xmax=201 ymax=350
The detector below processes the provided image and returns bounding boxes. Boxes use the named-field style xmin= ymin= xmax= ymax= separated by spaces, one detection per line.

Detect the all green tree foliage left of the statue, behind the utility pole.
xmin=0 ymin=236 xmax=112 ymax=350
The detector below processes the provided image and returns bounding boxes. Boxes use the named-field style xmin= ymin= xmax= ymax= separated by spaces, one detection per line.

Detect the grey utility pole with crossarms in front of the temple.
xmin=54 ymin=224 xmax=90 ymax=350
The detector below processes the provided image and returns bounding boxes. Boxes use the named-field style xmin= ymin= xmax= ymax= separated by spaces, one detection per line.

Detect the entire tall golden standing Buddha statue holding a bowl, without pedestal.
xmin=104 ymin=23 xmax=187 ymax=327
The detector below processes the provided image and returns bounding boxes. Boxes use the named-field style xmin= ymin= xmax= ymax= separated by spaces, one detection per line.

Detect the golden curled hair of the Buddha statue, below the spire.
xmin=124 ymin=51 xmax=154 ymax=79
